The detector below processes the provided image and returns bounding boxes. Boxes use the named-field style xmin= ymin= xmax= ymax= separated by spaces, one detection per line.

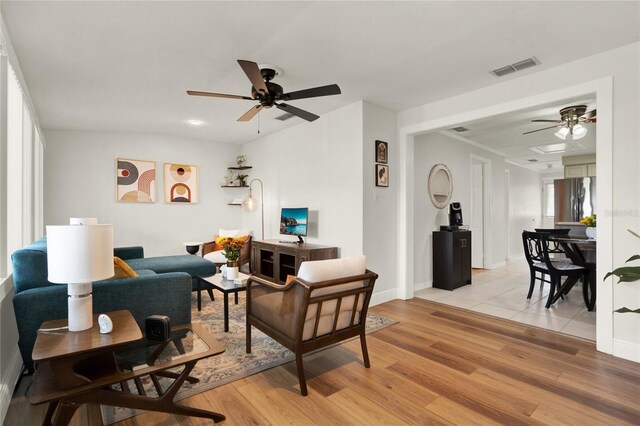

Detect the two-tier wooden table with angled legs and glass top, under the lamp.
xmin=29 ymin=311 xmax=225 ymax=425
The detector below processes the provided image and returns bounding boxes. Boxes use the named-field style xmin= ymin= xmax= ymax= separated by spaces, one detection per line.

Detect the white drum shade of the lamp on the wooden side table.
xmin=47 ymin=225 xmax=114 ymax=284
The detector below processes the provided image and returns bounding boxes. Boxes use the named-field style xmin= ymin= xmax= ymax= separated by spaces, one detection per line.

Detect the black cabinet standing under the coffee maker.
xmin=433 ymin=231 xmax=471 ymax=290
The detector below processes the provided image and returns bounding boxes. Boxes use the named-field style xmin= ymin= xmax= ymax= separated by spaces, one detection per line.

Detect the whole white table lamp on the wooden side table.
xmin=47 ymin=225 xmax=114 ymax=331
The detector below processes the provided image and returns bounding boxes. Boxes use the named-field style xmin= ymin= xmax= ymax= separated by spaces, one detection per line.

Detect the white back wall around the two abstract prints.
xmin=44 ymin=130 xmax=246 ymax=256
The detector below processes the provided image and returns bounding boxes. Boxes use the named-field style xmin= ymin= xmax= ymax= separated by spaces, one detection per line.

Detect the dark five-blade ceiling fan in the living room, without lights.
xmin=187 ymin=59 xmax=342 ymax=121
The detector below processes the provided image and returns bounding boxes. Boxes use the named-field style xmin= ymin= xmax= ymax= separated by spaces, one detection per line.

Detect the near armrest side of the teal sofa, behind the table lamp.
xmin=13 ymin=272 xmax=191 ymax=369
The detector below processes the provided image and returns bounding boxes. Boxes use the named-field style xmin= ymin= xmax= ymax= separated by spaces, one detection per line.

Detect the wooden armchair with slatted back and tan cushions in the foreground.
xmin=247 ymin=256 xmax=378 ymax=396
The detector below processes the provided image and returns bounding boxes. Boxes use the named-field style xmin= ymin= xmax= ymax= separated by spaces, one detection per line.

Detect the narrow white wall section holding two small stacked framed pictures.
xmin=362 ymin=102 xmax=398 ymax=305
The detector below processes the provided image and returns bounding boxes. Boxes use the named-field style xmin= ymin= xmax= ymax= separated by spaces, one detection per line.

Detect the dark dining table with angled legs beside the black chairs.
xmin=549 ymin=234 xmax=596 ymax=311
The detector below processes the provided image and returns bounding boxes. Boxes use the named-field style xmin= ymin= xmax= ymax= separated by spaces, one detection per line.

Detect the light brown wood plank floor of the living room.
xmin=5 ymin=299 xmax=640 ymax=426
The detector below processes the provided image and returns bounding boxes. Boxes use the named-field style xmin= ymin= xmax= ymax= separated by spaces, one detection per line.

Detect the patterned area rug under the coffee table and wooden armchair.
xmin=100 ymin=292 xmax=397 ymax=425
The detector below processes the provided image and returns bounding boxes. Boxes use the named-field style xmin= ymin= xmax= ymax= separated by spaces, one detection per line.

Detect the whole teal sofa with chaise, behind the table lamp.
xmin=11 ymin=237 xmax=215 ymax=370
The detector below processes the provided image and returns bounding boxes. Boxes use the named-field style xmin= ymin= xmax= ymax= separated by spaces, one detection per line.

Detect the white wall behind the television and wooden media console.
xmin=243 ymin=102 xmax=364 ymax=257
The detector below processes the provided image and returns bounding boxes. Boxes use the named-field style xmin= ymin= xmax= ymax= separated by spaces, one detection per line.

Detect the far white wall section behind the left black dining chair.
xmin=506 ymin=164 xmax=553 ymax=260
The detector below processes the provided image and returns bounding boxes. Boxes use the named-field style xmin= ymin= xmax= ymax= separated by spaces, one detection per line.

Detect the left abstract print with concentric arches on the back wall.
xmin=116 ymin=158 xmax=156 ymax=203
